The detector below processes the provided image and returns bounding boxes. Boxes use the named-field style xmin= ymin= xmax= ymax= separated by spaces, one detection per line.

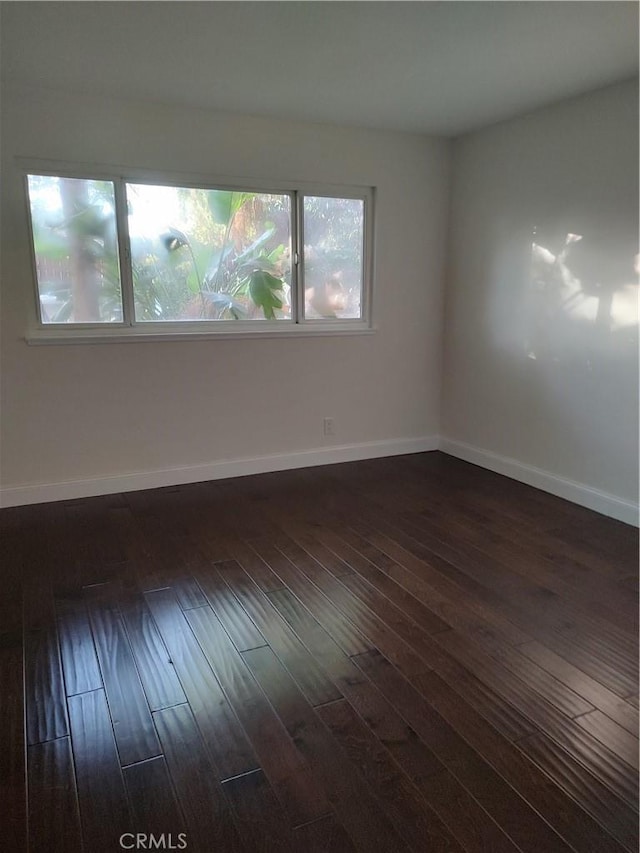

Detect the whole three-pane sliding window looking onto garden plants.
xmin=26 ymin=169 xmax=372 ymax=341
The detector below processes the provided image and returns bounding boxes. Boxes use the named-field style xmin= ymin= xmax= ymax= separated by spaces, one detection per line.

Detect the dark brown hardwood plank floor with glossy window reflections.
xmin=0 ymin=453 xmax=638 ymax=853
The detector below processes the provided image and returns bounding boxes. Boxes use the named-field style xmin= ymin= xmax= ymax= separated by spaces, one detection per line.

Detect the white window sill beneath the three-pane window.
xmin=24 ymin=322 xmax=376 ymax=346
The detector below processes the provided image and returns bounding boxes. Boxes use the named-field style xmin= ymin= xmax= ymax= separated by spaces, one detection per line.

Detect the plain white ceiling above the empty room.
xmin=1 ymin=0 xmax=638 ymax=135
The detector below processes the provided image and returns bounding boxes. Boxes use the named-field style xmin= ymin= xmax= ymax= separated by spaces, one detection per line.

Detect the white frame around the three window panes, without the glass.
xmin=18 ymin=158 xmax=375 ymax=344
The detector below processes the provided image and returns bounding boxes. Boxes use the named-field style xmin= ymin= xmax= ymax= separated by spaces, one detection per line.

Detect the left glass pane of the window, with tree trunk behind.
xmin=28 ymin=175 xmax=122 ymax=323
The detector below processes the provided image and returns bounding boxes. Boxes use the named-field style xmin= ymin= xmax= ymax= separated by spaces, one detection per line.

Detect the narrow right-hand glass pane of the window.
xmin=304 ymin=196 xmax=364 ymax=320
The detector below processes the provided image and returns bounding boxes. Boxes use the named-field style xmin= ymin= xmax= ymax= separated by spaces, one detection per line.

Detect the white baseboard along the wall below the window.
xmin=0 ymin=435 xmax=439 ymax=507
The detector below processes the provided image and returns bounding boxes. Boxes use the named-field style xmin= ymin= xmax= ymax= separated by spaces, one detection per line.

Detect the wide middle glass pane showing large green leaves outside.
xmin=127 ymin=184 xmax=291 ymax=322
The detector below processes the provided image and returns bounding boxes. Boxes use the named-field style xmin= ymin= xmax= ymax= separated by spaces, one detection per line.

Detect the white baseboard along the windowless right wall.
xmin=439 ymin=437 xmax=638 ymax=527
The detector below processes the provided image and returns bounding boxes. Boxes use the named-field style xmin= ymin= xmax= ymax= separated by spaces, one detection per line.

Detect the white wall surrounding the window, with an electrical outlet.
xmin=1 ymin=90 xmax=448 ymax=501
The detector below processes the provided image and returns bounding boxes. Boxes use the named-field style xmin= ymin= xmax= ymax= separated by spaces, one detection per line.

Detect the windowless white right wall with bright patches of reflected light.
xmin=442 ymin=82 xmax=638 ymax=520
